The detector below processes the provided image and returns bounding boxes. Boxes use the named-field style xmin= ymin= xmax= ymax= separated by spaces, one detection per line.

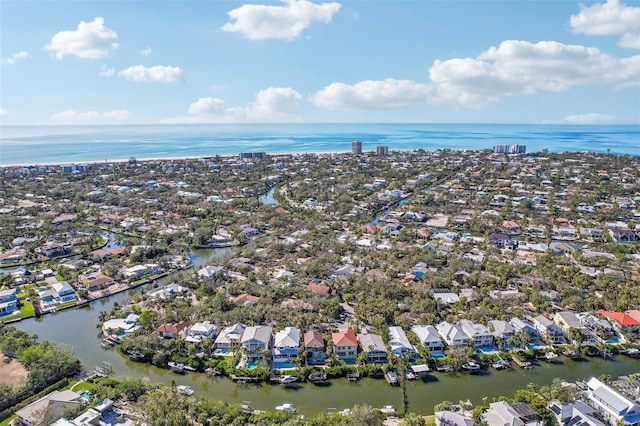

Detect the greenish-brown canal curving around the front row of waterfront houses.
xmin=7 ymin=245 xmax=640 ymax=415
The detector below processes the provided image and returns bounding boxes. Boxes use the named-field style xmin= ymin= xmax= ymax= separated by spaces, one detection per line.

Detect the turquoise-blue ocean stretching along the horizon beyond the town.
xmin=0 ymin=123 xmax=640 ymax=166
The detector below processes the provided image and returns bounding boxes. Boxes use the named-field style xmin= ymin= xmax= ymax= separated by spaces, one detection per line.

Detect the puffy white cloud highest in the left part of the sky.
xmin=44 ymin=17 xmax=118 ymax=59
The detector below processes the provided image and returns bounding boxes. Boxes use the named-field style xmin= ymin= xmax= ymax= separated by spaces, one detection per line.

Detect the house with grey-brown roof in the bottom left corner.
xmin=16 ymin=390 xmax=83 ymax=426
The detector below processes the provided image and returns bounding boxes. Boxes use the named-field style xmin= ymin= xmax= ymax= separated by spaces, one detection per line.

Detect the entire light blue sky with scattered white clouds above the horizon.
xmin=0 ymin=0 xmax=640 ymax=124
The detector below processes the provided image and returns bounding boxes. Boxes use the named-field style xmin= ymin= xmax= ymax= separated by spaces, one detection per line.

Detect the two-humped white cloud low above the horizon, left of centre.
xmin=165 ymin=87 xmax=302 ymax=123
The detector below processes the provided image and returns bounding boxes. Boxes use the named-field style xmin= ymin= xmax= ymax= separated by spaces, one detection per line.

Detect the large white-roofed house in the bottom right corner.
xmin=587 ymin=377 xmax=640 ymax=426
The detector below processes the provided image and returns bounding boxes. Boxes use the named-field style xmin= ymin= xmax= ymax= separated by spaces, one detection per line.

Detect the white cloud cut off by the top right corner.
xmin=569 ymin=0 xmax=640 ymax=49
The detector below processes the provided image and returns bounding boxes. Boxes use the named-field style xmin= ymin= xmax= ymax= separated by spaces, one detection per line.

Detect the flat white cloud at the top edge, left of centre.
xmin=221 ymin=0 xmax=340 ymax=40
